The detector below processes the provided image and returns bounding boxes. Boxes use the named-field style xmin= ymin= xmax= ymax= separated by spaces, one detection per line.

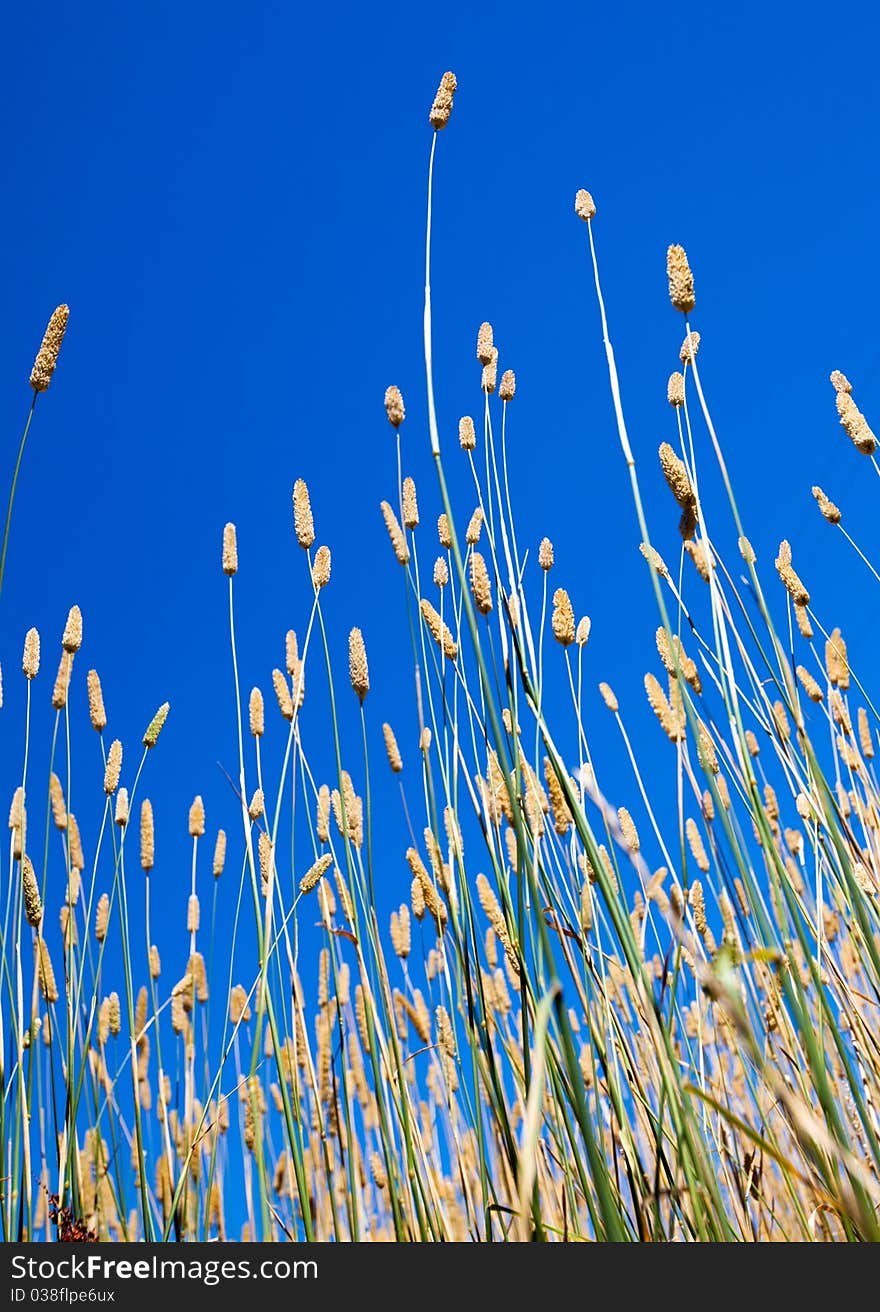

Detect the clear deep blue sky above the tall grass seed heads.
xmin=0 ymin=0 xmax=880 ymax=1159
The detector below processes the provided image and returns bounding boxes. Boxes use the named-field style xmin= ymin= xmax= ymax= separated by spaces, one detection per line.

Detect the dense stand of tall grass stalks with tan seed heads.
xmin=0 ymin=73 xmax=880 ymax=1241
